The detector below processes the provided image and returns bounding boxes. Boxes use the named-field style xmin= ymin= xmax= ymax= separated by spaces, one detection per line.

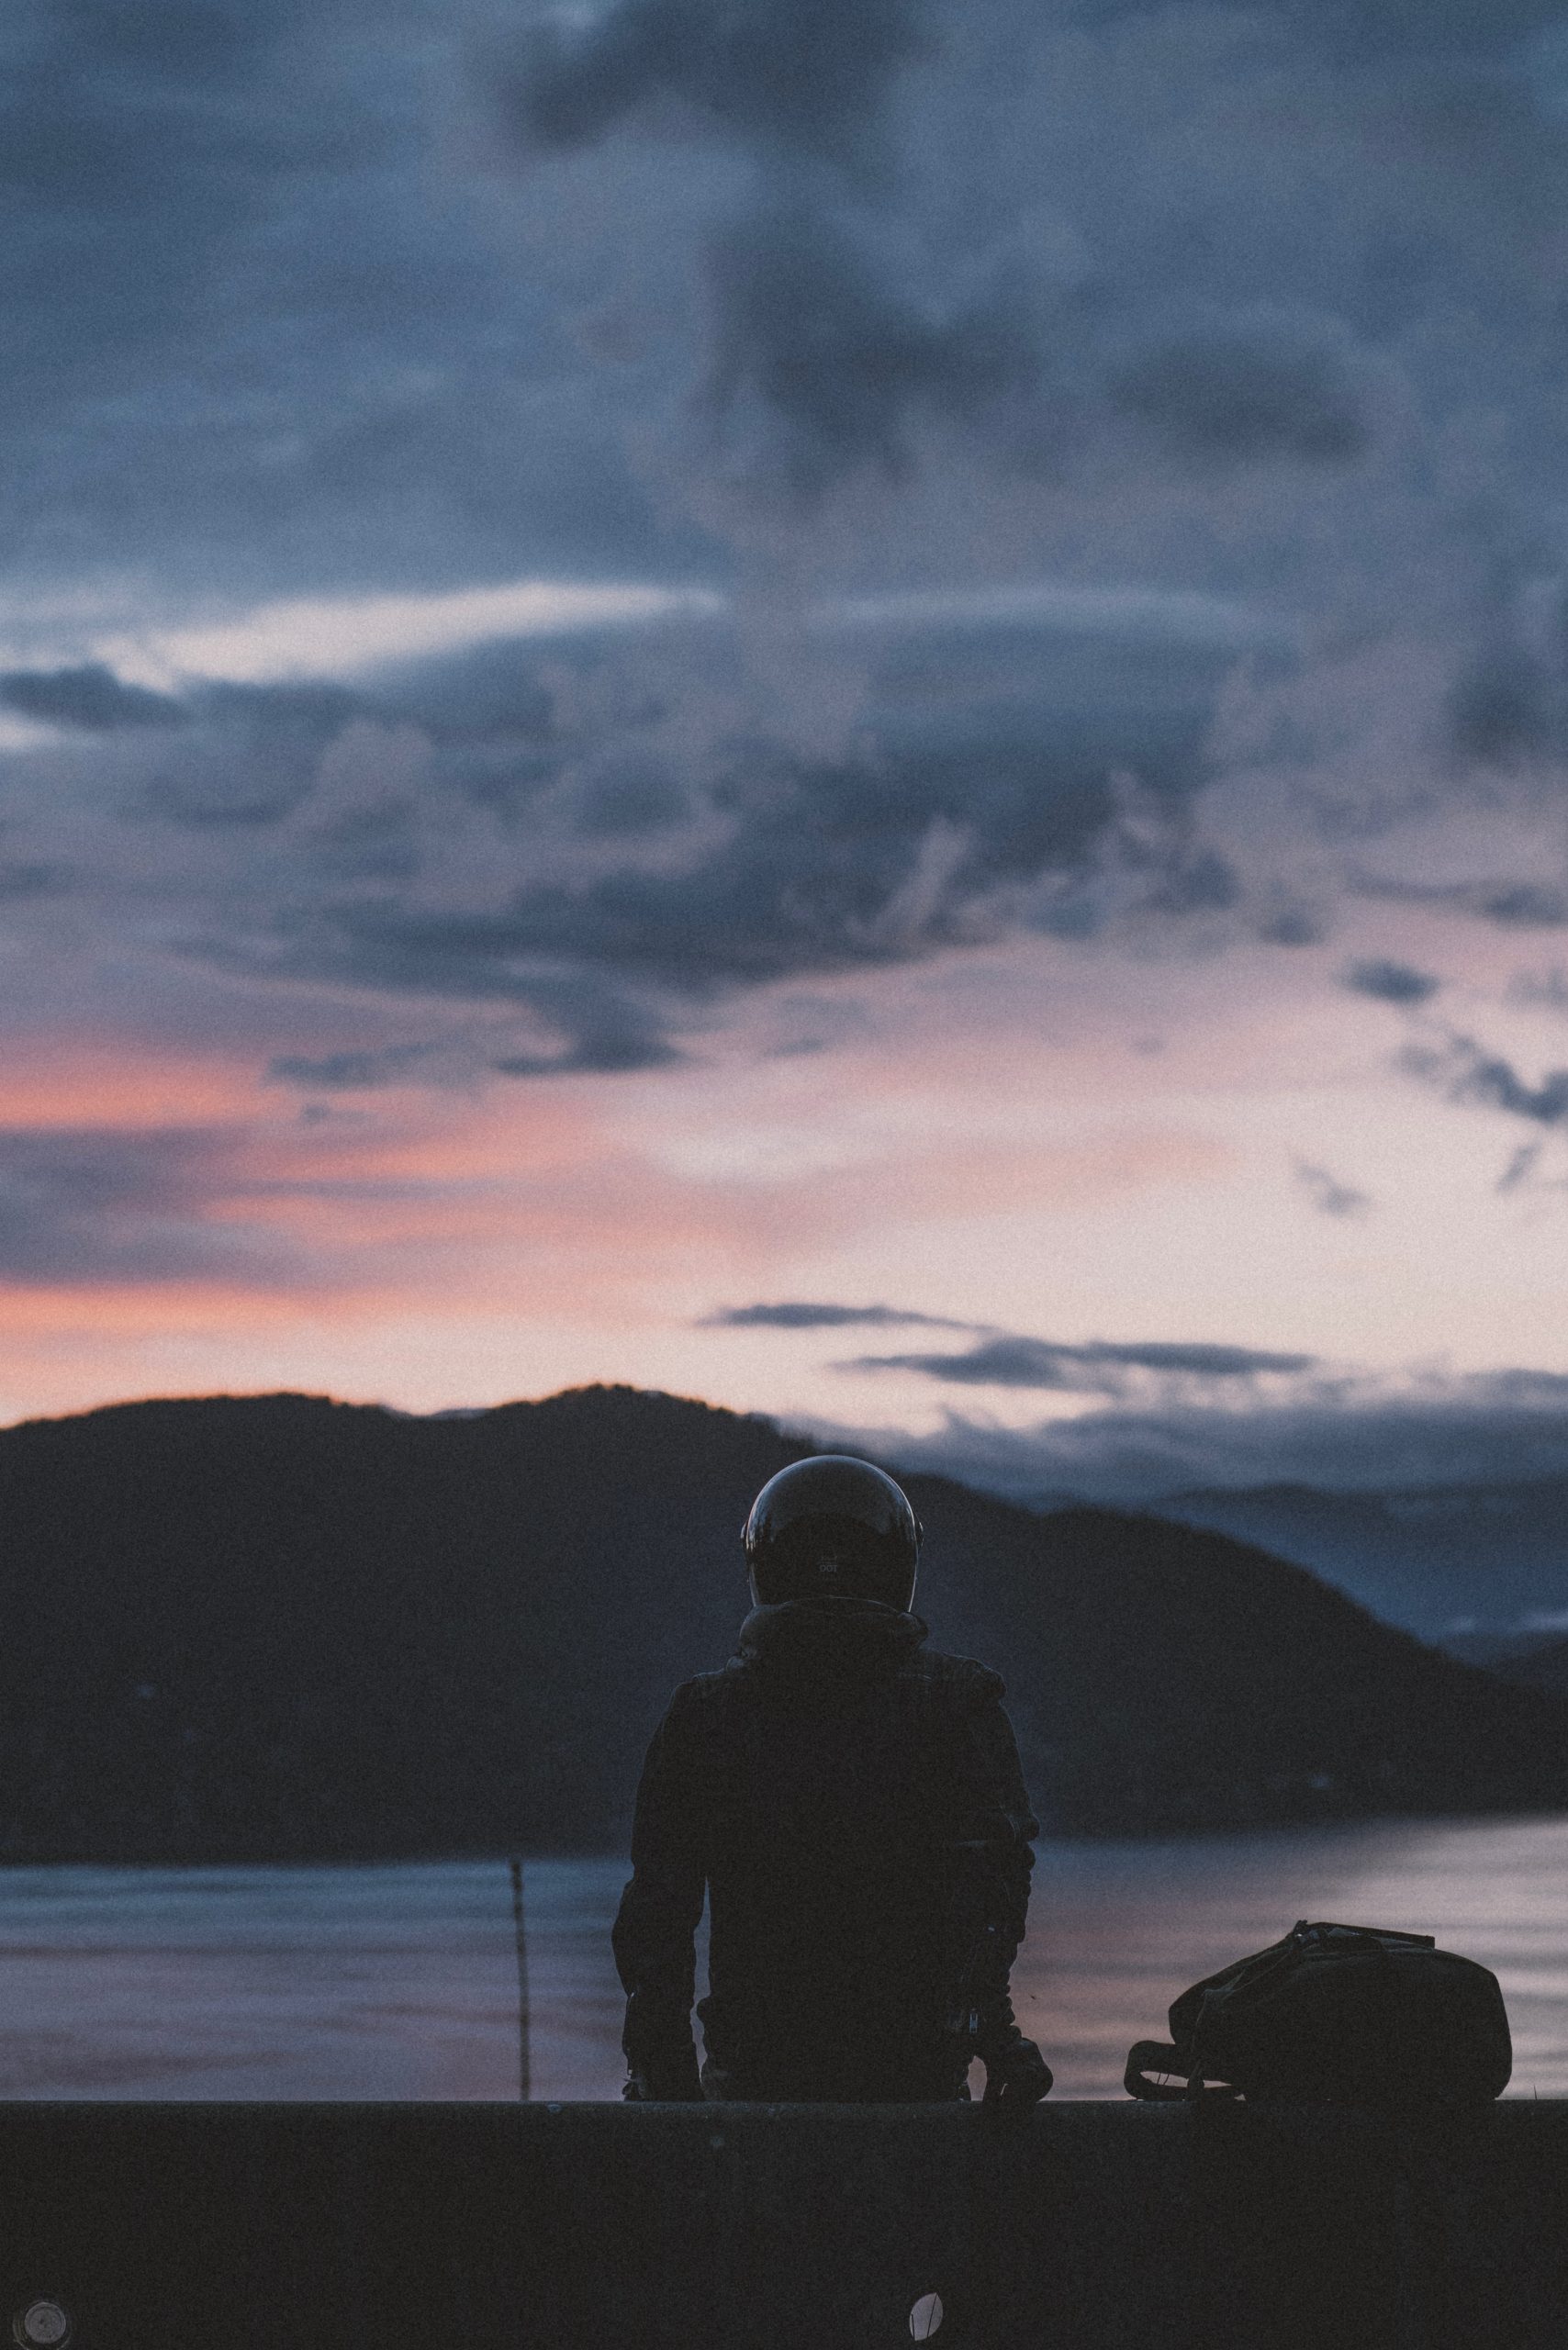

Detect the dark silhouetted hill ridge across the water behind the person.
xmin=0 ymin=1386 xmax=1568 ymax=1862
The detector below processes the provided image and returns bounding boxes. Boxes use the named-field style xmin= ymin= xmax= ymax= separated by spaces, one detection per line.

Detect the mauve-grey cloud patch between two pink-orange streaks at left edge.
xmin=0 ymin=1125 xmax=291 ymax=1285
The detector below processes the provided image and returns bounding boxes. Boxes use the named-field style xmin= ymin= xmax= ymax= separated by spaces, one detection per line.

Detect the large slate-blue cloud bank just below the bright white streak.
xmin=0 ymin=552 xmax=1270 ymax=1091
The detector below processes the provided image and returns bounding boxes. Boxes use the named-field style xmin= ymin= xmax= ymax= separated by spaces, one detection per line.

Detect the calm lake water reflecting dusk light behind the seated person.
xmin=0 ymin=1818 xmax=1568 ymax=2098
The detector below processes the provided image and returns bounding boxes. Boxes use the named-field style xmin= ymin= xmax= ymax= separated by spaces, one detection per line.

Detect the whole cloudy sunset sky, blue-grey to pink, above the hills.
xmin=0 ymin=0 xmax=1568 ymax=1494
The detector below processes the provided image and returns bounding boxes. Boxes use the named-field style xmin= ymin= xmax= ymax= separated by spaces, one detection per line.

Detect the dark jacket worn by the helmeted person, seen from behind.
xmin=613 ymin=1598 xmax=1036 ymax=2098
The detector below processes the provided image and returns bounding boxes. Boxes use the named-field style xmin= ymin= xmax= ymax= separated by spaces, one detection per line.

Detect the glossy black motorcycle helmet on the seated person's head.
xmin=741 ymin=1452 xmax=922 ymax=1607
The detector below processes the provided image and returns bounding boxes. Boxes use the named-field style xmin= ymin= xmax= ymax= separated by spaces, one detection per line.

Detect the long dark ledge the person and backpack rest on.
xmin=0 ymin=2101 xmax=1568 ymax=2350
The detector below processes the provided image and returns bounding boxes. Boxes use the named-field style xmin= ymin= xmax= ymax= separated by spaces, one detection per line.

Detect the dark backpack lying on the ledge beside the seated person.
xmin=1124 ymin=1918 xmax=1514 ymax=2108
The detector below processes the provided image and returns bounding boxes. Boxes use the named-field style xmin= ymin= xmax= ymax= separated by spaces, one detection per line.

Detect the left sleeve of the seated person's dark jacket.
xmin=611 ymin=1690 xmax=708 ymax=2080
